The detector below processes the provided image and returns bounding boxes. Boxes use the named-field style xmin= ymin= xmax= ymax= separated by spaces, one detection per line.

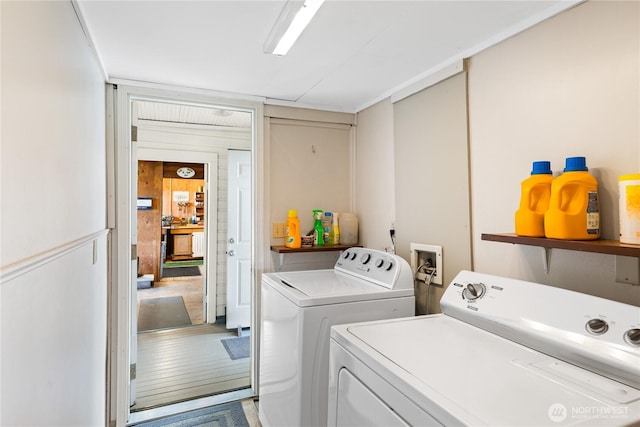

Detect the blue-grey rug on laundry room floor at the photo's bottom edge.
xmin=133 ymin=402 xmax=249 ymax=427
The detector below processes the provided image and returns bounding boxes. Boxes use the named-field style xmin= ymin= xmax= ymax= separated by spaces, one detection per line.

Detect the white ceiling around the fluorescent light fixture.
xmin=76 ymin=0 xmax=578 ymax=112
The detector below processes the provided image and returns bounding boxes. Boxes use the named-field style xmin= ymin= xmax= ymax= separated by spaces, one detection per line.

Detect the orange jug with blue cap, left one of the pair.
xmin=516 ymin=161 xmax=553 ymax=237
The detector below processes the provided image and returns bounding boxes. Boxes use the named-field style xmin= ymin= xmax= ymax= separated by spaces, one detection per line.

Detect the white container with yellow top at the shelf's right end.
xmin=618 ymin=173 xmax=640 ymax=245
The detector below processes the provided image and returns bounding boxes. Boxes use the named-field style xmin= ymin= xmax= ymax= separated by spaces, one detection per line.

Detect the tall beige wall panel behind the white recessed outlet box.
xmin=393 ymin=73 xmax=471 ymax=314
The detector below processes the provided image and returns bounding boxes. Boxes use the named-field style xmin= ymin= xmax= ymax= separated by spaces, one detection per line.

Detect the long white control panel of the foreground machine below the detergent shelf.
xmin=440 ymin=271 xmax=640 ymax=388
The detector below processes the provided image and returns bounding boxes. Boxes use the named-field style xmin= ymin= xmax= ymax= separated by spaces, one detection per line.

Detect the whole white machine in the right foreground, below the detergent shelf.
xmin=328 ymin=271 xmax=640 ymax=427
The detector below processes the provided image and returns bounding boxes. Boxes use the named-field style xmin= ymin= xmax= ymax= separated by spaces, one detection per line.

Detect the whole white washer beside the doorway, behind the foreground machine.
xmin=258 ymin=248 xmax=415 ymax=427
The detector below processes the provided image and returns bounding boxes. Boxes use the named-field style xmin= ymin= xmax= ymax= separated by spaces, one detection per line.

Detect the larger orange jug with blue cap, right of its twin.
xmin=544 ymin=157 xmax=600 ymax=240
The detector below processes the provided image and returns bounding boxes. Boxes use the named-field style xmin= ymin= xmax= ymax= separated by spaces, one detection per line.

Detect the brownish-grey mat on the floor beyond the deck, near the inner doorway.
xmin=138 ymin=296 xmax=191 ymax=332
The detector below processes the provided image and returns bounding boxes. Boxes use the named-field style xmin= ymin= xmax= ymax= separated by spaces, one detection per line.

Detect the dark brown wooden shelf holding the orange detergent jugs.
xmin=482 ymin=233 xmax=640 ymax=258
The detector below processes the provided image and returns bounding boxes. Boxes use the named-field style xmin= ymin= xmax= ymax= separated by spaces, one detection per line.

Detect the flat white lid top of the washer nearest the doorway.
xmin=263 ymin=270 xmax=413 ymax=307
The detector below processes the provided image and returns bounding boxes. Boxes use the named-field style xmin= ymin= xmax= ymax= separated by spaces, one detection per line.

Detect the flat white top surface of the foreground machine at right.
xmin=331 ymin=315 xmax=640 ymax=426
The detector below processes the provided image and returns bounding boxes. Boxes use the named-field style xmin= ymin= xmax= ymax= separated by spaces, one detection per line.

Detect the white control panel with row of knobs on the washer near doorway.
xmin=334 ymin=247 xmax=413 ymax=289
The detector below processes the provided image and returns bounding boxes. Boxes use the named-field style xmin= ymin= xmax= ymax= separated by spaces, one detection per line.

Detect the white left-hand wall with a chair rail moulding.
xmin=0 ymin=1 xmax=107 ymax=426
